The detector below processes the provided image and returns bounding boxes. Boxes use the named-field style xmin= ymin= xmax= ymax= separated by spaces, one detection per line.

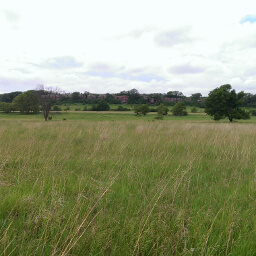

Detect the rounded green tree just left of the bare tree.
xmin=13 ymin=91 xmax=39 ymax=114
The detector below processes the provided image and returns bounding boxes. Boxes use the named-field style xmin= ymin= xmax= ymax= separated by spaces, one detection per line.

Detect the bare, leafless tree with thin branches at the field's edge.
xmin=37 ymin=85 xmax=61 ymax=121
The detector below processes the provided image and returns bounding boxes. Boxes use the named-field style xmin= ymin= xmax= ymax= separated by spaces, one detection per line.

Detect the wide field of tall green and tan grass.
xmin=0 ymin=112 xmax=256 ymax=255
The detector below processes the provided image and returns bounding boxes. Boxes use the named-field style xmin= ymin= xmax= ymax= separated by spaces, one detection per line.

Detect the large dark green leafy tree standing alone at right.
xmin=205 ymin=84 xmax=250 ymax=122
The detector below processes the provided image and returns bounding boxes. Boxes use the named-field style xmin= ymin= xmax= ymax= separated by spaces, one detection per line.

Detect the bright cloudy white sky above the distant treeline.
xmin=0 ymin=0 xmax=256 ymax=96
